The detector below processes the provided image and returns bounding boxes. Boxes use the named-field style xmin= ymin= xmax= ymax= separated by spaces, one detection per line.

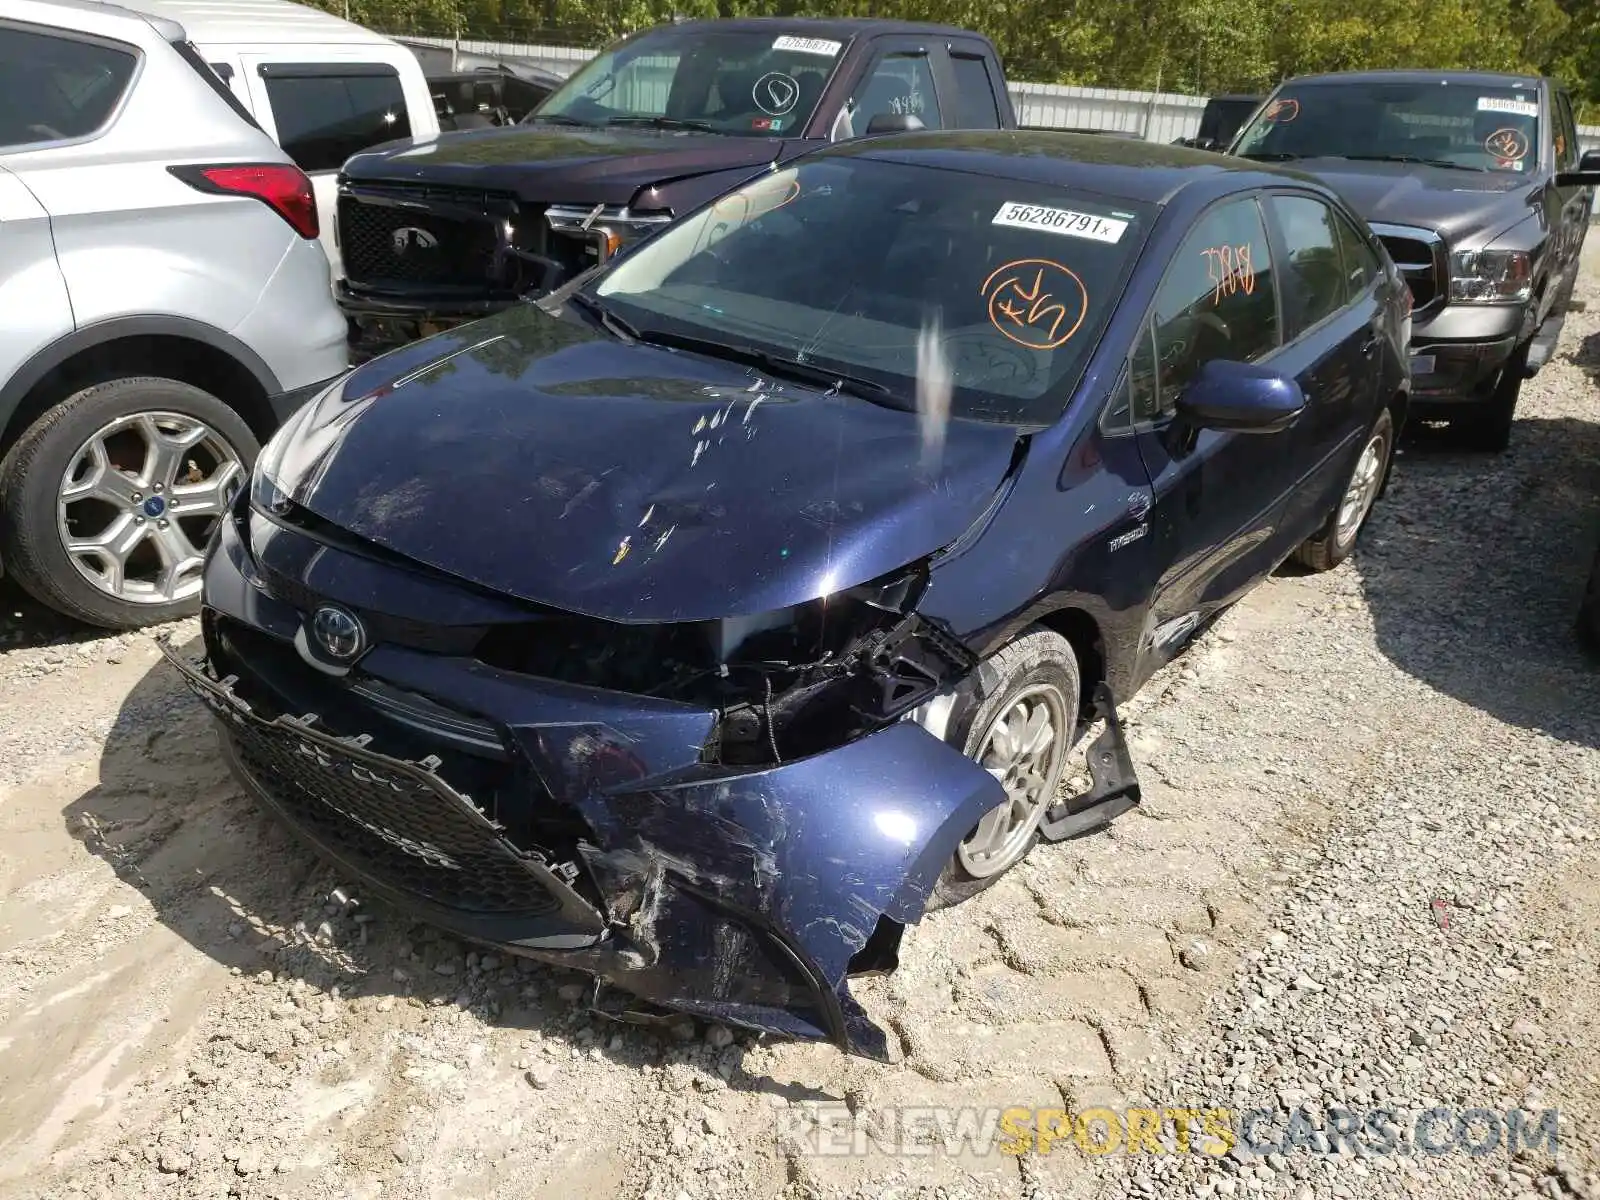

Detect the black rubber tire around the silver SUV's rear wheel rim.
xmin=0 ymin=378 xmax=261 ymax=629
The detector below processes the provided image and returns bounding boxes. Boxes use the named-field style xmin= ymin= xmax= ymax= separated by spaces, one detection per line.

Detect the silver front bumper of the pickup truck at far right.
xmin=1411 ymin=304 xmax=1533 ymax=406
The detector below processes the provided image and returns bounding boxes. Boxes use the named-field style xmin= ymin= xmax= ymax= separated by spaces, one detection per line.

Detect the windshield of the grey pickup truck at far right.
xmin=1234 ymin=78 xmax=1539 ymax=171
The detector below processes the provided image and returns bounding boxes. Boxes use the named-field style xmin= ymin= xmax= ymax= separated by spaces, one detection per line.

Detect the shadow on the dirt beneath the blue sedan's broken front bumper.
xmin=62 ymin=637 xmax=821 ymax=1099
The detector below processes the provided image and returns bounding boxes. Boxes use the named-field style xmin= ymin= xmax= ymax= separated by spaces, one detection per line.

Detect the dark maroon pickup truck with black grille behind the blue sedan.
xmin=338 ymin=18 xmax=1016 ymax=357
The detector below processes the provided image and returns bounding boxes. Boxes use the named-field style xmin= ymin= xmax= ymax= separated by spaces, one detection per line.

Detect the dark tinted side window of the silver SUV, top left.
xmin=0 ymin=24 xmax=139 ymax=149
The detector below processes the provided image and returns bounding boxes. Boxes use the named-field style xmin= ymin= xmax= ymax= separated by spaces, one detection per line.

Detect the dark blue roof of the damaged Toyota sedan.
xmin=838 ymin=130 xmax=1322 ymax=205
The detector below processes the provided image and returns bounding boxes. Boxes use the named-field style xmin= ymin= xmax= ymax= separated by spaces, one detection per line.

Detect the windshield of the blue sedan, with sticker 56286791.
xmin=586 ymin=157 xmax=1155 ymax=426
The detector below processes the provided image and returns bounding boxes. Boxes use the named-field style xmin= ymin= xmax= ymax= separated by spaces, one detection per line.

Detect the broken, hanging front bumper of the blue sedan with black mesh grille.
xmin=166 ymin=508 xmax=1003 ymax=1061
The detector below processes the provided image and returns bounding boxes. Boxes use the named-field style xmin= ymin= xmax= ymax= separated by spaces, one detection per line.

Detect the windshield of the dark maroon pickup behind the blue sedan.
xmin=526 ymin=26 xmax=845 ymax=138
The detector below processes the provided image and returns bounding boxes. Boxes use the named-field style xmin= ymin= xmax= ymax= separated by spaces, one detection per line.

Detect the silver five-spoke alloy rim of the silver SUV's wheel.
xmin=56 ymin=411 xmax=245 ymax=605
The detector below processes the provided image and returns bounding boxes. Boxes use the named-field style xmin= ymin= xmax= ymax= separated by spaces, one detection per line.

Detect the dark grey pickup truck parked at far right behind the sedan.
xmin=1229 ymin=70 xmax=1600 ymax=451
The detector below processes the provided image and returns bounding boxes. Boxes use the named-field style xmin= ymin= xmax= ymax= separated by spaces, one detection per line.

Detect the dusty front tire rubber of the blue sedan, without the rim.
xmin=928 ymin=626 xmax=1082 ymax=910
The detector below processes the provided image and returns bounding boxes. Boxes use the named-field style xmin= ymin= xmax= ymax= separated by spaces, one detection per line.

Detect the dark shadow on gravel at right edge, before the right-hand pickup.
xmin=1355 ymin=412 xmax=1600 ymax=747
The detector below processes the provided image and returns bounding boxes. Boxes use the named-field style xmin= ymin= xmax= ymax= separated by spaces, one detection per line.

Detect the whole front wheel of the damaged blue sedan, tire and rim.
xmin=928 ymin=626 xmax=1080 ymax=909
